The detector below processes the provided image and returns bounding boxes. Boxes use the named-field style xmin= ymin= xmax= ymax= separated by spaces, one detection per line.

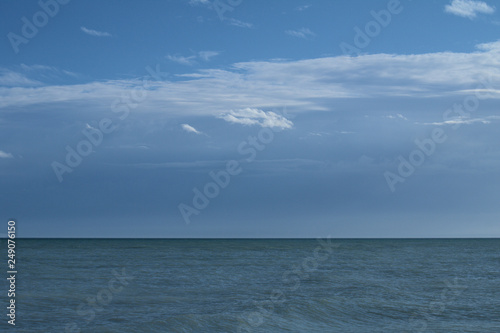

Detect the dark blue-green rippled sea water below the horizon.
xmin=0 ymin=239 xmax=500 ymax=333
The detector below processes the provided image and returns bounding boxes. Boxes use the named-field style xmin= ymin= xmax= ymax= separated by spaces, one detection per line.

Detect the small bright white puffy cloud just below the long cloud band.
xmin=219 ymin=108 xmax=293 ymax=129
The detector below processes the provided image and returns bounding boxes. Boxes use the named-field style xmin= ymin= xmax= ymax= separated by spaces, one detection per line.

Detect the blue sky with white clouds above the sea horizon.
xmin=0 ymin=0 xmax=500 ymax=238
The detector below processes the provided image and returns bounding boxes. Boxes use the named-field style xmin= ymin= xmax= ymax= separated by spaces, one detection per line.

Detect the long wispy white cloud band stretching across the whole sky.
xmin=0 ymin=42 xmax=500 ymax=116
